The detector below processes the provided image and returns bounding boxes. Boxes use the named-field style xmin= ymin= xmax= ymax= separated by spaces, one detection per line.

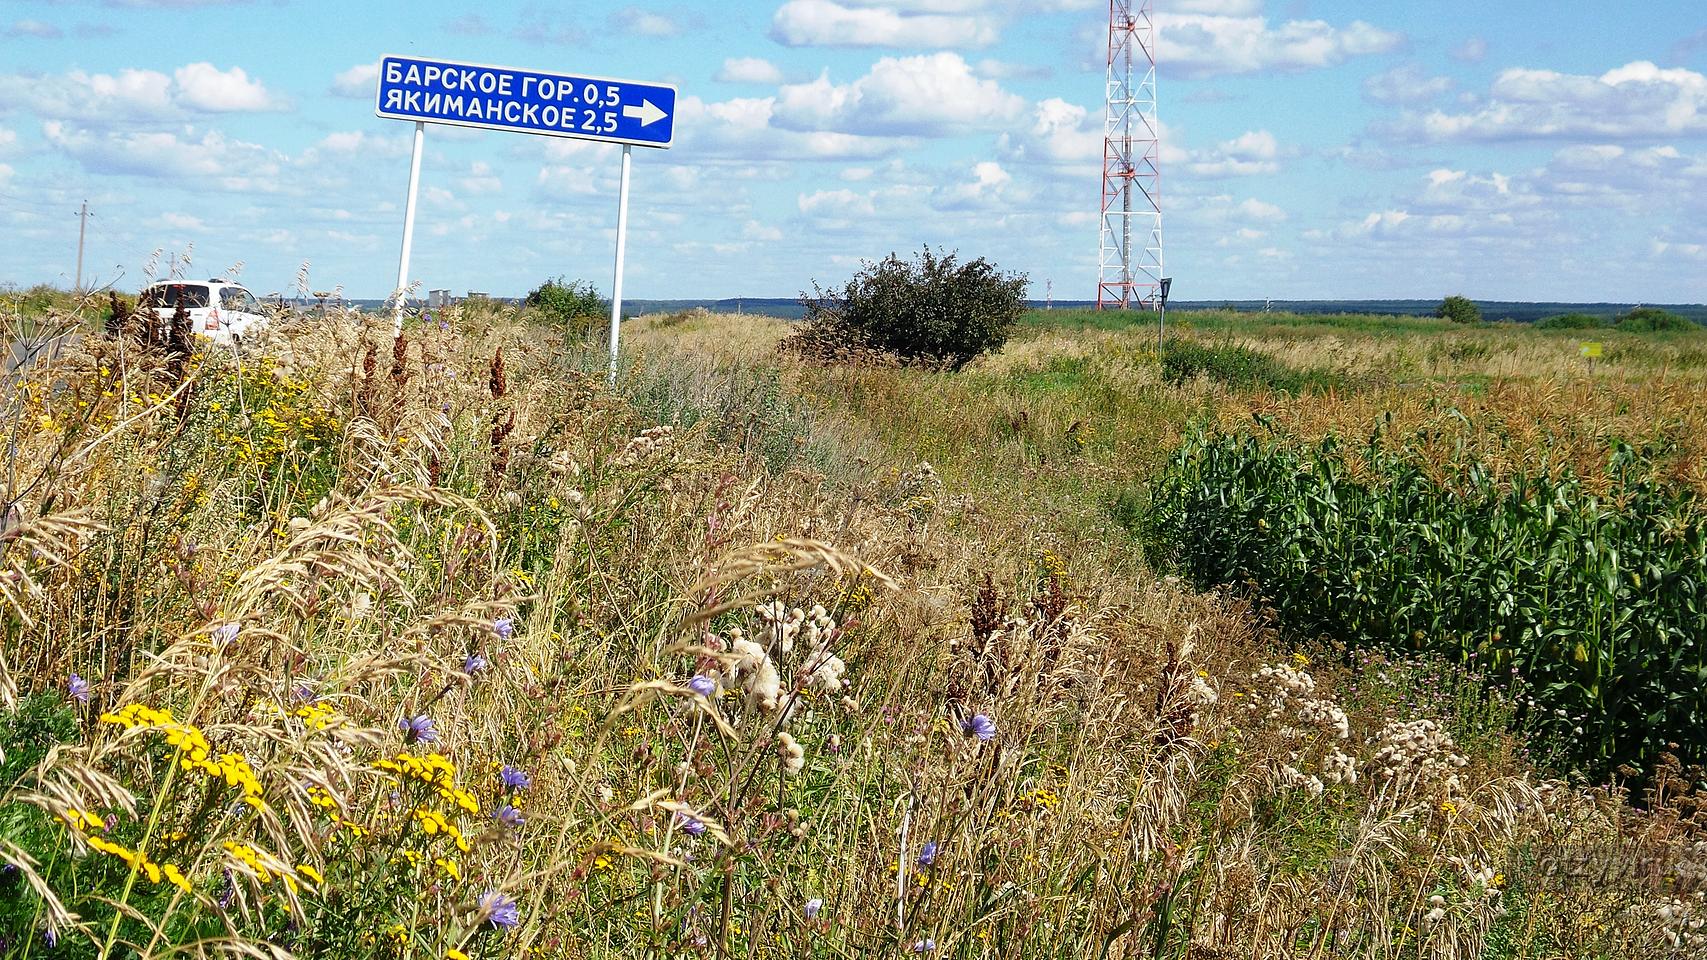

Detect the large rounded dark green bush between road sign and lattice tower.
xmin=790 ymin=246 xmax=1026 ymax=369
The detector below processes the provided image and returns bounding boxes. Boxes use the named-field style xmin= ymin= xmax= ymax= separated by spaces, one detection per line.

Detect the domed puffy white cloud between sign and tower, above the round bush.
xmin=777 ymin=53 xmax=1026 ymax=137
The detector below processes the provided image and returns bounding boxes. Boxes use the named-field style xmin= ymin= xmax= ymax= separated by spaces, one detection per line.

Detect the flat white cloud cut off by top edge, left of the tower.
xmin=770 ymin=0 xmax=1000 ymax=48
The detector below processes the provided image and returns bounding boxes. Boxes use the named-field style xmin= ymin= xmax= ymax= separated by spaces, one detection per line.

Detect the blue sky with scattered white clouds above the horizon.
xmin=0 ymin=0 xmax=1707 ymax=302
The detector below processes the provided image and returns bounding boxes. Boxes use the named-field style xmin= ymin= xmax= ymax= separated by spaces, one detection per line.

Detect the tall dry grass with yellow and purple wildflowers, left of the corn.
xmin=0 ymin=300 xmax=1702 ymax=958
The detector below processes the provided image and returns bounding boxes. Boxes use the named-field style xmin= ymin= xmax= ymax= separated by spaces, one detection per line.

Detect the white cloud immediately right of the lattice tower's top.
xmin=1156 ymin=12 xmax=1405 ymax=77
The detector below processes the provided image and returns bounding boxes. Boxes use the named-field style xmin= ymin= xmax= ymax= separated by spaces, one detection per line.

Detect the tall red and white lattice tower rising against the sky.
xmin=1096 ymin=0 xmax=1162 ymax=309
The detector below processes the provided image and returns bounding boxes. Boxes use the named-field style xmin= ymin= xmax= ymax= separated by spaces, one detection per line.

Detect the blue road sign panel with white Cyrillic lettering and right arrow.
xmin=374 ymin=56 xmax=676 ymax=147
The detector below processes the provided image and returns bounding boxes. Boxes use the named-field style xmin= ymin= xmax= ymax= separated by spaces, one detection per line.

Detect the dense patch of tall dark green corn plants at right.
xmin=1144 ymin=436 xmax=1707 ymax=776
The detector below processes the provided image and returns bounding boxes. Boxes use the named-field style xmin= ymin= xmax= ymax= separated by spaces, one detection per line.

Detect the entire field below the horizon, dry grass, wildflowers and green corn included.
xmin=0 ymin=293 xmax=1707 ymax=960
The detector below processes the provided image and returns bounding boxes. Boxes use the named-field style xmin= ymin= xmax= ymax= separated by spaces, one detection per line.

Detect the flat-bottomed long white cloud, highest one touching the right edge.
xmin=1391 ymin=60 xmax=1707 ymax=142
